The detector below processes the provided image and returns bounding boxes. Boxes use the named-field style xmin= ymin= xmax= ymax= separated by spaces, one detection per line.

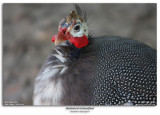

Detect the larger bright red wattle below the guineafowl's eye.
xmin=69 ymin=35 xmax=89 ymax=48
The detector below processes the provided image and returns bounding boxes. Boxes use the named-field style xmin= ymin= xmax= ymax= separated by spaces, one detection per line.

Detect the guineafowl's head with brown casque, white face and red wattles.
xmin=52 ymin=11 xmax=89 ymax=48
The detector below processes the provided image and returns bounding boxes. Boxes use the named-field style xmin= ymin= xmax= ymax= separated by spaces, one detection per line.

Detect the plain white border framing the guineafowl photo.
xmin=0 ymin=0 xmax=160 ymax=115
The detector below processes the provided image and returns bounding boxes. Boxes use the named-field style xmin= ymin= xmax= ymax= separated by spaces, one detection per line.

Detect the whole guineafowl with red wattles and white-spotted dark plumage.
xmin=33 ymin=4 xmax=157 ymax=105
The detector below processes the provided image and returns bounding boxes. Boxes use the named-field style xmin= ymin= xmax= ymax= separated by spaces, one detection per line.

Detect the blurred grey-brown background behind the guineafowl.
xmin=2 ymin=4 xmax=157 ymax=105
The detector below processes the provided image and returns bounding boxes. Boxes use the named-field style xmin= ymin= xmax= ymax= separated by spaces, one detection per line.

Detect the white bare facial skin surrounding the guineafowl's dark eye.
xmin=70 ymin=19 xmax=88 ymax=37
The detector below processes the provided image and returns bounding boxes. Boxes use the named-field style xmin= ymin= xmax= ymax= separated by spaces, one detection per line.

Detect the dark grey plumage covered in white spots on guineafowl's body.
xmin=92 ymin=36 xmax=157 ymax=105
